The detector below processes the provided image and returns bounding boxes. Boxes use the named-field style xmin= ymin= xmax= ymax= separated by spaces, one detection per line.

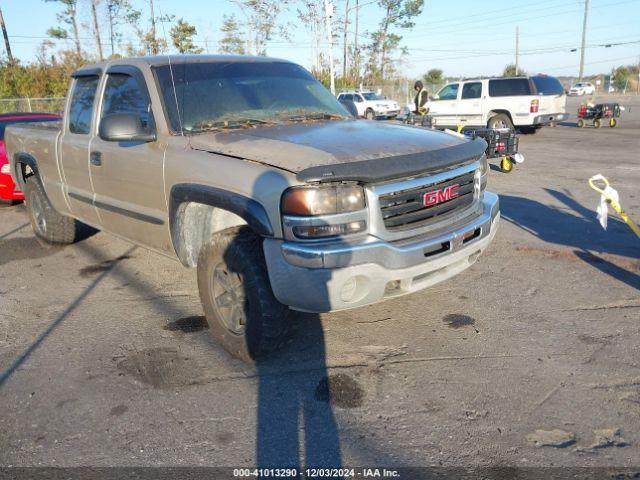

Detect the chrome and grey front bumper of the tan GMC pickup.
xmin=264 ymin=192 xmax=500 ymax=312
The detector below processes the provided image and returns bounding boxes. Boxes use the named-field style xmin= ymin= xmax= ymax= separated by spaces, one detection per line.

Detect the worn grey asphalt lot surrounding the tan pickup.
xmin=0 ymin=97 xmax=640 ymax=478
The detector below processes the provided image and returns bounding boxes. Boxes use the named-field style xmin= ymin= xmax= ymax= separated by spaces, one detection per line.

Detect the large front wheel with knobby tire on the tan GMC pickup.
xmin=198 ymin=227 xmax=292 ymax=362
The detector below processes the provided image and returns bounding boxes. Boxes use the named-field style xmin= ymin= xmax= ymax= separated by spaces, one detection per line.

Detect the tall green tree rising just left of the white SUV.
xmin=369 ymin=0 xmax=424 ymax=81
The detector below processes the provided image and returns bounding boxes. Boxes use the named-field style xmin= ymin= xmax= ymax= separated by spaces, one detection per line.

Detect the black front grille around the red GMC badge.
xmin=379 ymin=171 xmax=475 ymax=230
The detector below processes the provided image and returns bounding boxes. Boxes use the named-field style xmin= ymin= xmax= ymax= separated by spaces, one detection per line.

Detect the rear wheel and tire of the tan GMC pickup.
xmin=24 ymin=175 xmax=84 ymax=245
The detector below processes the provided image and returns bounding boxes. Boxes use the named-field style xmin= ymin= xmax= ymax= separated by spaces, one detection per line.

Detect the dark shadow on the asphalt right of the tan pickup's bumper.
xmin=500 ymin=189 xmax=640 ymax=290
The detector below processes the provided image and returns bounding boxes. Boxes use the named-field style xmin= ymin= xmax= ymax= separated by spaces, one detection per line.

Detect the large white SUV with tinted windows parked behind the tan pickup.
xmin=427 ymin=75 xmax=567 ymax=133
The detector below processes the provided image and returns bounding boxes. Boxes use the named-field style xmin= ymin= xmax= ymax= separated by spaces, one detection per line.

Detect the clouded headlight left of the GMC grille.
xmin=281 ymin=185 xmax=365 ymax=217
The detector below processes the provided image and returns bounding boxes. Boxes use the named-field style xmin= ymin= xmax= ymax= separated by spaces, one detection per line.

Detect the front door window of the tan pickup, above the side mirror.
xmin=102 ymin=73 xmax=149 ymax=126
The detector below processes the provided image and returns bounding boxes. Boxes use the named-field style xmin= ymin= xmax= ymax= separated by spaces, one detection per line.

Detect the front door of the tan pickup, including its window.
xmin=89 ymin=66 xmax=171 ymax=255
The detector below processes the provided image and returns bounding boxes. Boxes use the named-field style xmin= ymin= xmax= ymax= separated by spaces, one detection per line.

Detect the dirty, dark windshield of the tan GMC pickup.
xmin=156 ymin=62 xmax=349 ymax=133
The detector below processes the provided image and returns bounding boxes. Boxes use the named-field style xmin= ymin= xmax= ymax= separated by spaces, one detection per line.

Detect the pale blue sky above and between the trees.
xmin=0 ymin=0 xmax=640 ymax=77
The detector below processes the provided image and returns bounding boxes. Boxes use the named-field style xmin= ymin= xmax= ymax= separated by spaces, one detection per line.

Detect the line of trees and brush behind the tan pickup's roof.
xmin=0 ymin=0 xmax=424 ymax=98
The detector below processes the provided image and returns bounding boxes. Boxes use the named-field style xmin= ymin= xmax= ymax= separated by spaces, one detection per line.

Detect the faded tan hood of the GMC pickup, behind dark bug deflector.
xmin=190 ymin=120 xmax=466 ymax=173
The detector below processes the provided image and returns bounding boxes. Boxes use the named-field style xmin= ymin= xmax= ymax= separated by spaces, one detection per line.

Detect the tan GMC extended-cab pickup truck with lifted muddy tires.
xmin=6 ymin=55 xmax=500 ymax=360
